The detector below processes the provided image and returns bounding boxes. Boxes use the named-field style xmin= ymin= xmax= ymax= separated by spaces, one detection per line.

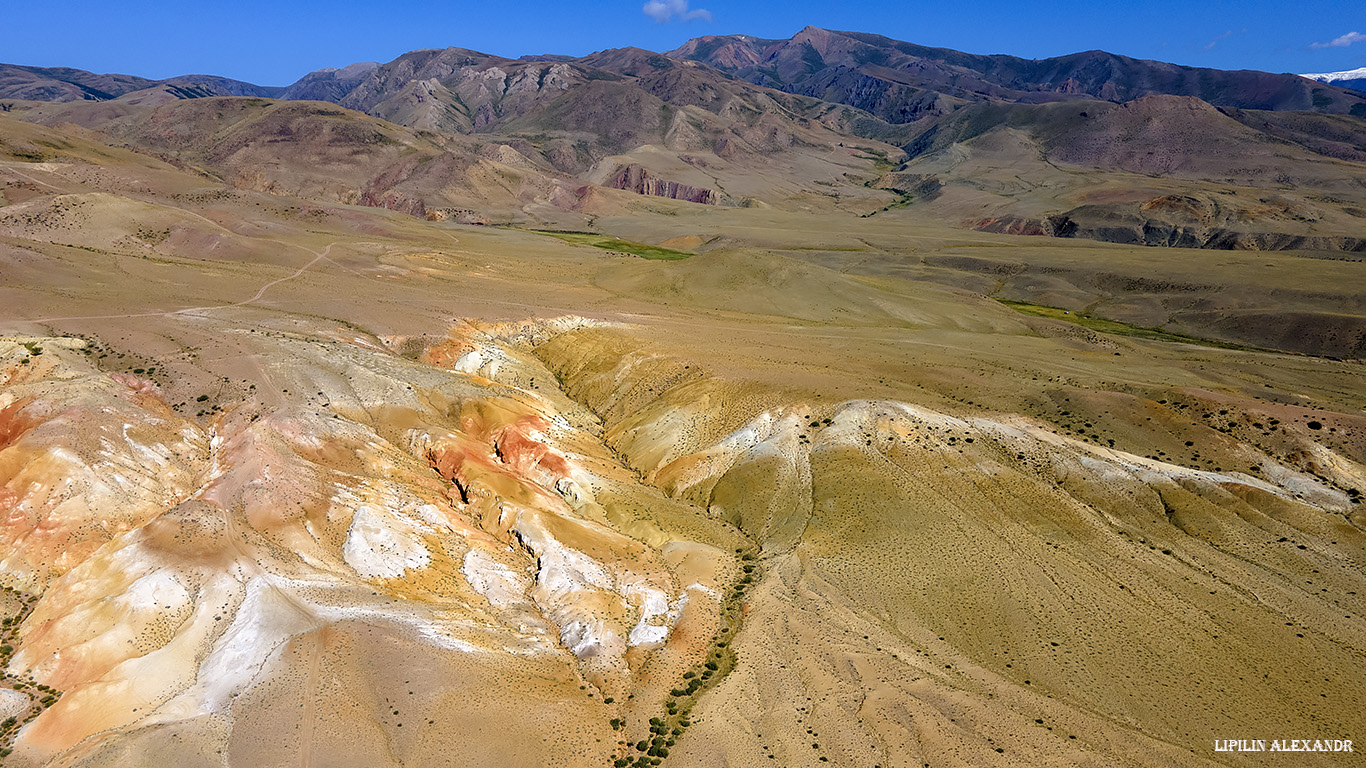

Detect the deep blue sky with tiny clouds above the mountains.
xmin=8 ymin=0 xmax=1366 ymax=85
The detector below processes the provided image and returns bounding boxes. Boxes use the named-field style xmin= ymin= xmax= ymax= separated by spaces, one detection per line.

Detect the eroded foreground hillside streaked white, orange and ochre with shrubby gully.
xmin=0 ymin=307 xmax=1366 ymax=765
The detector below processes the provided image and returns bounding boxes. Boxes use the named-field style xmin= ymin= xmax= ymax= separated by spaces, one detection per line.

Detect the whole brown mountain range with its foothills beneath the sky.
xmin=8 ymin=27 xmax=1366 ymax=251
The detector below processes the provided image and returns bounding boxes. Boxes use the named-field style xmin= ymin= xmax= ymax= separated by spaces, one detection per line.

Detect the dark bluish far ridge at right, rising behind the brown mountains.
xmin=668 ymin=26 xmax=1366 ymax=123
